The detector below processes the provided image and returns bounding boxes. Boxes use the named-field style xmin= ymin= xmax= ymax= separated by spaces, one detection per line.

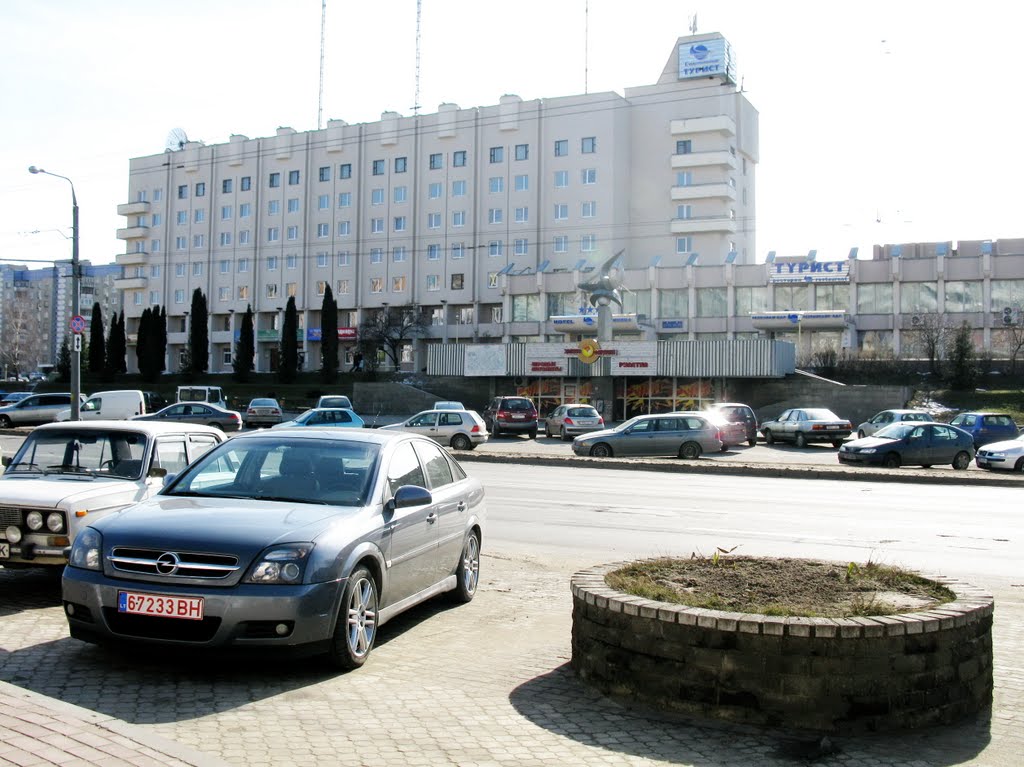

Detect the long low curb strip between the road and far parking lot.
xmin=457 ymin=451 xmax=1024 ymax=487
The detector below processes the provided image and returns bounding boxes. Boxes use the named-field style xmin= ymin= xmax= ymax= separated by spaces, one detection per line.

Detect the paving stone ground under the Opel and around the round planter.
xmin=0 ymin=552 xmax=1024 ymax=767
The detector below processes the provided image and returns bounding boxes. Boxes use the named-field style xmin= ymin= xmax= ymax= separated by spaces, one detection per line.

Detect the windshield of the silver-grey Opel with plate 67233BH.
xmin=163 ymin=436 xmax=380 ymax=506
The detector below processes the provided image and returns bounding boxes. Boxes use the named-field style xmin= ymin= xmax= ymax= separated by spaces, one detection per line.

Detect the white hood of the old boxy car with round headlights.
xmin=0 ymin=474 xmax=152 ymax=510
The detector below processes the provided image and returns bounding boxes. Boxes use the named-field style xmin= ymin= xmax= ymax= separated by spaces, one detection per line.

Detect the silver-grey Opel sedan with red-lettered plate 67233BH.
xmin=62 ymin=428 xmax=485 ymax=669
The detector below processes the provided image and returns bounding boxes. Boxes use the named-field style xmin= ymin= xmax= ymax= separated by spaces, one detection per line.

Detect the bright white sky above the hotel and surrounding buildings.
xmin=0 ymin=0 xmax=1024 ymax=267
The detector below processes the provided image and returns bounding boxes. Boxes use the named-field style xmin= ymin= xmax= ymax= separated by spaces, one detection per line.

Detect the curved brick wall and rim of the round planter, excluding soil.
xmin=571 ymin=562 xmax=993 ymax=734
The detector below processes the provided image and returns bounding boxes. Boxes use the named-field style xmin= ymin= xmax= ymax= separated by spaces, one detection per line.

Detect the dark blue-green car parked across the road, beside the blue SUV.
xmin=838 ymin=421 xmax=974 ymax=470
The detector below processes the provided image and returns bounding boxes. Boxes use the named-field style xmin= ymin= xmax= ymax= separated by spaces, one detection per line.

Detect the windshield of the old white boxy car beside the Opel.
xmin=4 ymin=429 xmax=150 ymax=479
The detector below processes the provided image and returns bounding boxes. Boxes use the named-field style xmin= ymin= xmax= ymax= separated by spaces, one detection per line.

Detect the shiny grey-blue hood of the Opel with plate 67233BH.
xmin=94 ymin=496 xmax=362 ymax=555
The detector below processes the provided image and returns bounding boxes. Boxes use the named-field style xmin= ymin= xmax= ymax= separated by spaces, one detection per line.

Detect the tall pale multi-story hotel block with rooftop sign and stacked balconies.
xmin=116 ymin=35 xmax=758 ymax=371
